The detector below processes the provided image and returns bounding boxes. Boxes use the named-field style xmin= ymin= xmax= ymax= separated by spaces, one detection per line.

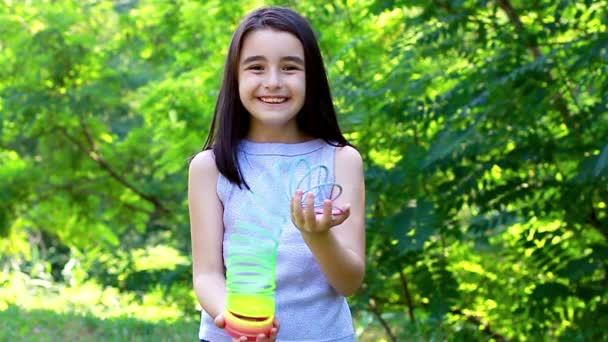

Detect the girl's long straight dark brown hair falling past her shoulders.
xmin=203 ymin=7 xmax=351 ymax=189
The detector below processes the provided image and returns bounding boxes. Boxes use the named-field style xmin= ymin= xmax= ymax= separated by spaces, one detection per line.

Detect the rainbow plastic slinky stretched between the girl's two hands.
xmin=224 ymin=159 xmax=342 ymax=341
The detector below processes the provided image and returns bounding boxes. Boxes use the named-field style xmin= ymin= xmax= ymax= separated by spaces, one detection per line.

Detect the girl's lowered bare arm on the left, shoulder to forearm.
xmin=188 ymin=150 xmax=226 ymax=318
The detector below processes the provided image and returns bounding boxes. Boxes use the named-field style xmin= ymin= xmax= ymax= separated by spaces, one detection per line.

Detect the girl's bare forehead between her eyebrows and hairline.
xmin=240 ymin=29 xmax=304 ymax=62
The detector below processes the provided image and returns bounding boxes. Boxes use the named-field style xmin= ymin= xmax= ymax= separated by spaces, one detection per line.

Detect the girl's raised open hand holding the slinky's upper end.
xmin=291 ymin=190 xmax=350 ymax=234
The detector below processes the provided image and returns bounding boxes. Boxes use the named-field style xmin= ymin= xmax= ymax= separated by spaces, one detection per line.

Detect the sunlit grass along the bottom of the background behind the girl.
xmin=0 ymin=271 xmax=388 ymax=342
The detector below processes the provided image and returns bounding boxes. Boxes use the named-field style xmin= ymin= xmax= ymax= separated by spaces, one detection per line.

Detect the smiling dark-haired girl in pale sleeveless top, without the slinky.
xmin=188 ymin=7 xmax=365 ymax=342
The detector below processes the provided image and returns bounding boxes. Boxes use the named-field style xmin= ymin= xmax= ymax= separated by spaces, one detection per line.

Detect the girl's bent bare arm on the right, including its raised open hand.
xmin=294 ymin=146 xmax=365 ymax=296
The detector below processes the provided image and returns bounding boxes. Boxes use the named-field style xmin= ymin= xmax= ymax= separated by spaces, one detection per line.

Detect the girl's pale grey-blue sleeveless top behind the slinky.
xmin=199 ymin=139 xmax=355 ymax=342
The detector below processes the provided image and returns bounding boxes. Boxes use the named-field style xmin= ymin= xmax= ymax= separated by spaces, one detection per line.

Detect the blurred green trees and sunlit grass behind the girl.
xmin=0 ymin=0 xmax=608 ymax=341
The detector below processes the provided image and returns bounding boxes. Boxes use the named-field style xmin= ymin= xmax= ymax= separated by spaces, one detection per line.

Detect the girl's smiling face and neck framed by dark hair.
xmin=238 ymin=29 xmax=306 ymax=140
